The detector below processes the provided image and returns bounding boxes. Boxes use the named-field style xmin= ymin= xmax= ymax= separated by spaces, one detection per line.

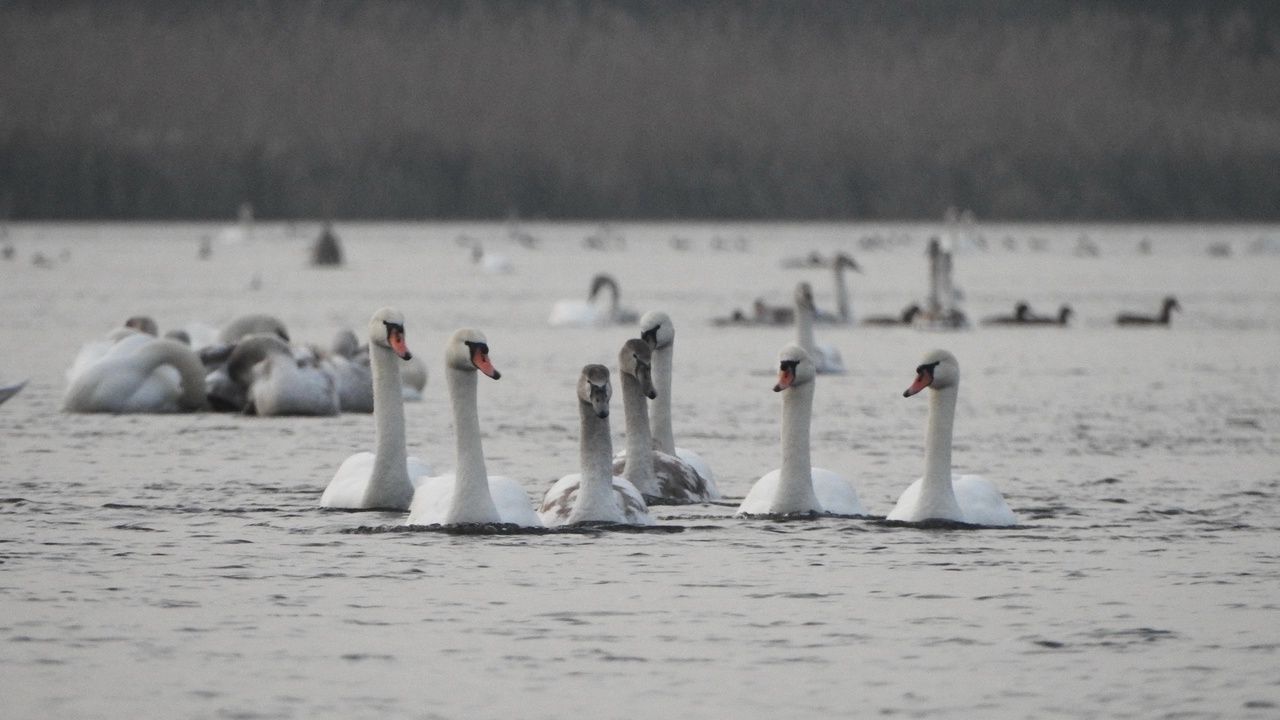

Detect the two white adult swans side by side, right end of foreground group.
xmin=737 ymin=345 xmax=1018 ymax=527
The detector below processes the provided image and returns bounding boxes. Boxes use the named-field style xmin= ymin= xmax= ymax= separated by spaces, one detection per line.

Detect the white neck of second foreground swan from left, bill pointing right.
xmin=445 ymin=368 xmax=502 ymax=524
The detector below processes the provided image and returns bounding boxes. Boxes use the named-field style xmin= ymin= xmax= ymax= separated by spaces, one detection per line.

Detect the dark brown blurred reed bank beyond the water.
xmin=0 ymin=0 xmax=1280 ymax=220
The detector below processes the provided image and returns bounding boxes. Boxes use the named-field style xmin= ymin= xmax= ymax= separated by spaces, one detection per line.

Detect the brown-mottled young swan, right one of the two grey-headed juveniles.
xmin=613 ymin=338 xmax=719 ymax=505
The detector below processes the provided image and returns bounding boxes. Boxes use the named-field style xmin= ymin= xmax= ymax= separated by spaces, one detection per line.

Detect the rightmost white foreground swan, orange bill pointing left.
xmin=887 ymin=350 xmax=1018 ymax=527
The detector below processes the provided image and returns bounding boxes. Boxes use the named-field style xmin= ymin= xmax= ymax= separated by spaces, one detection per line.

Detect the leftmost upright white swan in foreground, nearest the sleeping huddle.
xmin=320 ymin=307 xmax=434 ymax=510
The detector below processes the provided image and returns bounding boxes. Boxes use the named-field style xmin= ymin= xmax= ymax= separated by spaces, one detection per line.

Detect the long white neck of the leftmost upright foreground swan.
xmin=365 ymin=343 xmax=413 ymax=507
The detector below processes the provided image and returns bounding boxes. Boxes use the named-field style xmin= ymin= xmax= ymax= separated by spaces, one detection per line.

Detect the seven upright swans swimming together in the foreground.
xmin=309 ymin=302 xmax=1016 ymax=527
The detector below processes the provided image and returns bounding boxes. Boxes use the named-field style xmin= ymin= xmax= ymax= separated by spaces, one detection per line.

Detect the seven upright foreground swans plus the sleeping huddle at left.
xmin=63 ymin=292 xmax=1016 ymax=528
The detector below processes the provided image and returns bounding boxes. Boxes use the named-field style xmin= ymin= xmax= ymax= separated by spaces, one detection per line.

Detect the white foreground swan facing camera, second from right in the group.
xmin=737 ymin=345 xmax=867 ymax=515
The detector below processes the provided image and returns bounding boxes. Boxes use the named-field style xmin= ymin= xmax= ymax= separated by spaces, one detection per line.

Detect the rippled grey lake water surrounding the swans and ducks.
xmin=0 ymin=224 xmax=1280 ymax=717
